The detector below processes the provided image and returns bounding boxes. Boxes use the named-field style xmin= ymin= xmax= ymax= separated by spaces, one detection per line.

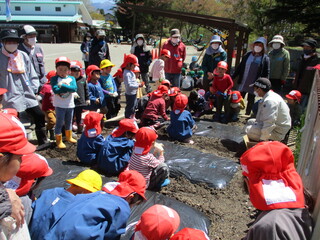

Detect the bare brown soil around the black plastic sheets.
xmin=39 ymin=115 xmax=256 ymax=240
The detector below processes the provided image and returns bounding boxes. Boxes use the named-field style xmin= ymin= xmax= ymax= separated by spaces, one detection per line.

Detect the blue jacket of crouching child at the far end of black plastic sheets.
xmin=167 ymin=110 xmax=195 ymax=141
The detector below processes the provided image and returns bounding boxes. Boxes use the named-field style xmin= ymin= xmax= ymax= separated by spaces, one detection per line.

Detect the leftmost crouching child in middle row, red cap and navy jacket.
xmin=77 ymin=112 xmax=104 ymax=165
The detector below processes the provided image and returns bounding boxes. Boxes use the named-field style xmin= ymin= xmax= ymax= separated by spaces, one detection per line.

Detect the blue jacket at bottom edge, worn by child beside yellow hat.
xmin=44 ymin=191 xmax=130 ymax=240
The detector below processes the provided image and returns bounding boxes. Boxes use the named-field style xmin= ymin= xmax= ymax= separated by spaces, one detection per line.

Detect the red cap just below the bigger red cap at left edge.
xmin=16 ymin=153 xmax=53 ymax=196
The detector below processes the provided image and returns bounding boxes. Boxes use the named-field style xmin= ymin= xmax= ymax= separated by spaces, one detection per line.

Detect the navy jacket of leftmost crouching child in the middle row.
xmin=77 ymin=133 xmax=104 ymax=165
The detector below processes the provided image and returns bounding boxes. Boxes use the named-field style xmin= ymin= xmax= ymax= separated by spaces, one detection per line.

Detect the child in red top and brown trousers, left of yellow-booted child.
xmin=39 ymin=70 xmax=57 ymax=140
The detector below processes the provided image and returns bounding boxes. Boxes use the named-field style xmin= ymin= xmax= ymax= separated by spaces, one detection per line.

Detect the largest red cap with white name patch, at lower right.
xmin=240 ymin=141 xmax=305 ymax=211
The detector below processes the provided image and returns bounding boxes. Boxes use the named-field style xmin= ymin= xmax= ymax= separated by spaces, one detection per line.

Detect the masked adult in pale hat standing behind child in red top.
xmin=201 ymin=35 xmax=227 ymax=92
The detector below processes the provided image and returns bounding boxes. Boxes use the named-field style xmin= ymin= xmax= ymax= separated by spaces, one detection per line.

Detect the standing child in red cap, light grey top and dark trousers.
xmin=121 ymin=54 xmax=142 ymax=119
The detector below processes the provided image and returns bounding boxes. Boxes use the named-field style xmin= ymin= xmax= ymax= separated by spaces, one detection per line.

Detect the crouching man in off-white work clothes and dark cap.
xmin=245 ymin=78 xmax=291 ymax=141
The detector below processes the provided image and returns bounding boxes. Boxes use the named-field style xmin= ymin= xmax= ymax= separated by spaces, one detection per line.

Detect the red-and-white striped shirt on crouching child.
xmin=128 ymin=153 xmax=164 ymax=186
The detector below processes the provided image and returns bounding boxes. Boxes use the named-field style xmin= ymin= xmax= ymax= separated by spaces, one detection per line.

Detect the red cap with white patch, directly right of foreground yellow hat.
xmin=102 ymin=170 xmax=147 ymax=200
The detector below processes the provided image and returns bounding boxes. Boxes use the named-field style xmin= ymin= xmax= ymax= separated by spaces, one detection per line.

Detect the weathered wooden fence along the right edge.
xmin=297 ymin=70 xmax=320 ymax=240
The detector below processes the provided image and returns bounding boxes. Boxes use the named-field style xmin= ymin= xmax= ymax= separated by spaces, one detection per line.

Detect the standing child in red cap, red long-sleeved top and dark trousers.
xmin=211 ymin=61 xmax=233 ymax=123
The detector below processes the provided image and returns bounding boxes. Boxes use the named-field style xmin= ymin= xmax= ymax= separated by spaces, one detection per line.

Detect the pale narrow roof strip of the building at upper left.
xmin=0 ymin=15 xmax=82 ymax=22
